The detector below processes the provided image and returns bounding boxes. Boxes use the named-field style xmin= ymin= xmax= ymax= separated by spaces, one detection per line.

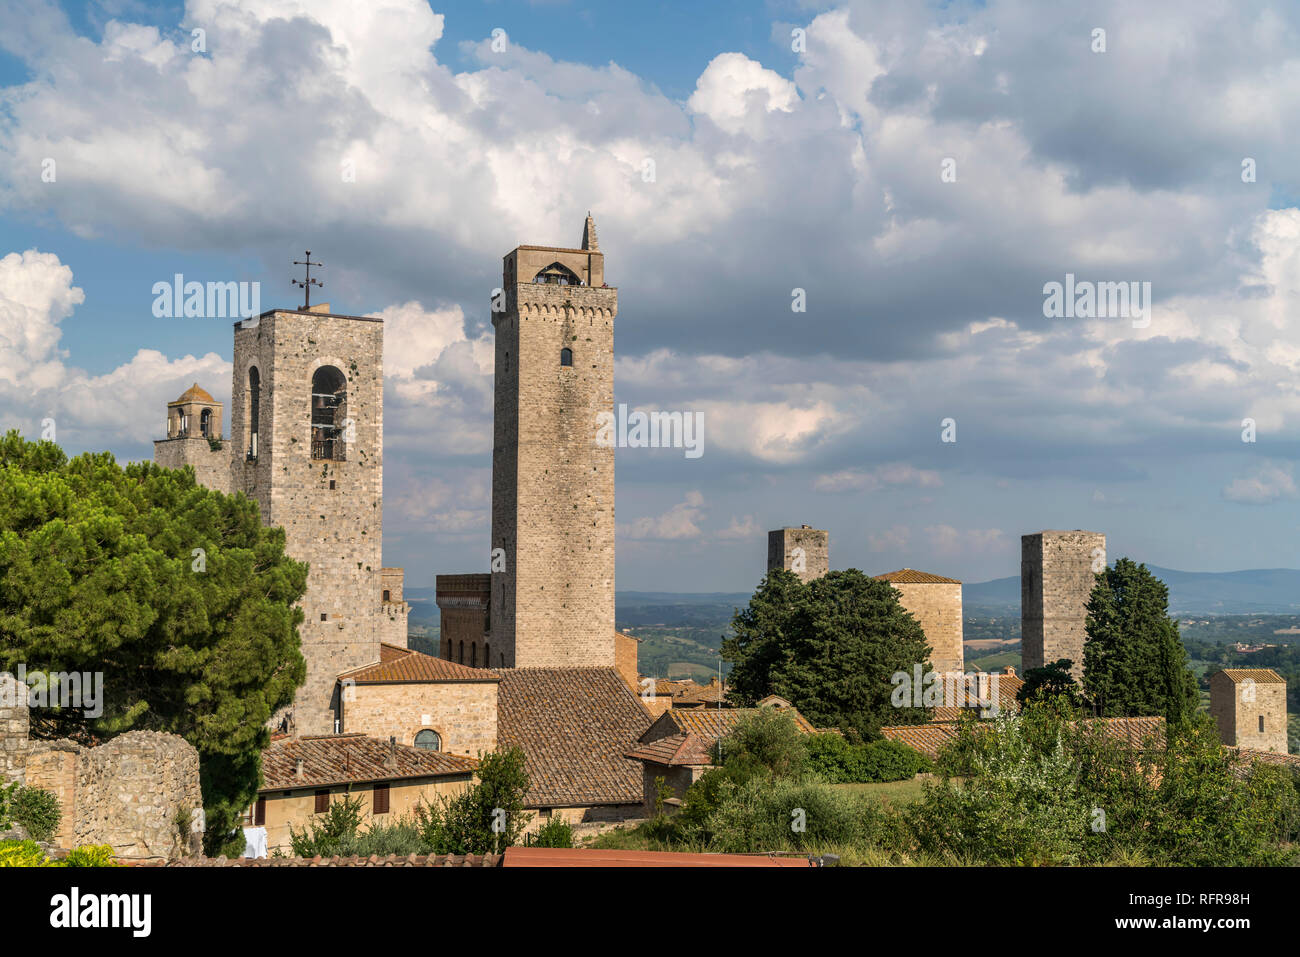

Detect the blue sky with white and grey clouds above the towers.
xmin=0 ymin=0 xmax=1300 ymax=590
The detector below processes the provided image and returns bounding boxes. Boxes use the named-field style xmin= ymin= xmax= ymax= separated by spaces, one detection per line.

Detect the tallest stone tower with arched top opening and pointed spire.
xmin=484 ymin=213 xmax=619 ymax=668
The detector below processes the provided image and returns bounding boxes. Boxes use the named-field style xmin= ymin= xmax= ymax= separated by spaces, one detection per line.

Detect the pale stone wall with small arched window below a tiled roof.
xmin=342 ymin=680 xmax=497 ymax=758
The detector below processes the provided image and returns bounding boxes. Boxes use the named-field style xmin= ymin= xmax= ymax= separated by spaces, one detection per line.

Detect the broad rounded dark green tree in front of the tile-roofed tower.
xmin=723 ymin=568 xmax=931 ymax=737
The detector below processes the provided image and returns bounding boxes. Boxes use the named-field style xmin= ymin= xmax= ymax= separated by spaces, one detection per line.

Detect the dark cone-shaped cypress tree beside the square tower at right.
xmin=1083 ymin=558 xmax=1197 ymax=724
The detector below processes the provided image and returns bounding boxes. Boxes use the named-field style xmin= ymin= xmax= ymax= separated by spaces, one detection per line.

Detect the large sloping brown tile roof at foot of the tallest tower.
xmin=495 ymin=668 xmax=650 ymax=807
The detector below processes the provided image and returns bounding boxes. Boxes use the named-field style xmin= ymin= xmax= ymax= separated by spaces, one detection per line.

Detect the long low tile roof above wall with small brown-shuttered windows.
xmin=260 ymin=735 xmax=478 ymax=792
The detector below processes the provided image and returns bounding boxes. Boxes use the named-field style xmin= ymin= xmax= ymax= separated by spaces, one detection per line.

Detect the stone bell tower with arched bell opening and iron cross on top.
xmin=230 ymin=303 xmax=408 ymax=735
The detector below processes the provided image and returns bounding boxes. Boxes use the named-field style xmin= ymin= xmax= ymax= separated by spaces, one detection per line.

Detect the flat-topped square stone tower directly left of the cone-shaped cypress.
xmin=1021 ymin=529 xmax=1106 ymax=680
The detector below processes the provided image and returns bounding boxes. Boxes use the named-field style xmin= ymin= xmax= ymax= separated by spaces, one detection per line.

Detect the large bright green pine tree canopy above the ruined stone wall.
xmin=0 ymin=432 xmax=307 ymax=852
